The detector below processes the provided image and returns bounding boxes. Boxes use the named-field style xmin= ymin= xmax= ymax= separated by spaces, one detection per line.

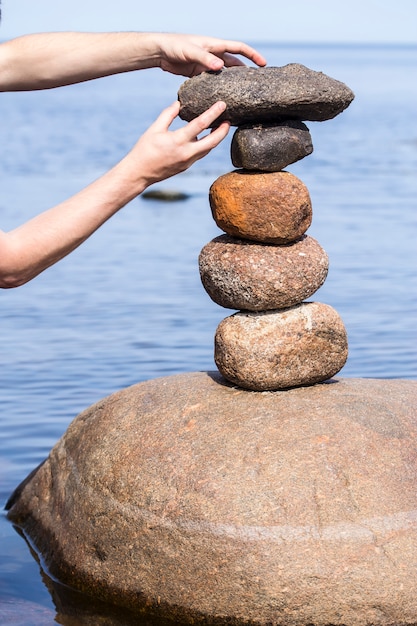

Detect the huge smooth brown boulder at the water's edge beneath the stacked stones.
xmin=8 ymin=372 xmax=417 ymax=626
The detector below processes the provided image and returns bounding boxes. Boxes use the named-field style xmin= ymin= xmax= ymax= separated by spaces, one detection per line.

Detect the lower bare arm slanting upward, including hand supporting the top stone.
xmin=0 ymin=102 xmax=229 ymax=288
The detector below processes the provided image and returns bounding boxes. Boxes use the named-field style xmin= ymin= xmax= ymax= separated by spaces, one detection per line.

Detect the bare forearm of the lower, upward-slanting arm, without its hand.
xmin=0 ymin=164 xmax=146 ymax=288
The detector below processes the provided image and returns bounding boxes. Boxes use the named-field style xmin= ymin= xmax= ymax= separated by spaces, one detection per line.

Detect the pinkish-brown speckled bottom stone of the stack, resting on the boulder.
xmin=214 ymin=302 xmax=348 ymax=391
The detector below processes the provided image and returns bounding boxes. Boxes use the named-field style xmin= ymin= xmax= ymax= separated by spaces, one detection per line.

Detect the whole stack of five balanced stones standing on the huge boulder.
xmin=178 ymin=64 xmax=354 ymax=391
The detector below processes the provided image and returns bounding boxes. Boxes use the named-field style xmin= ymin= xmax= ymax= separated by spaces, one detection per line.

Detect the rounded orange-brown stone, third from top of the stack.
xmin=209 ymin=170 xmax=312 ymax=244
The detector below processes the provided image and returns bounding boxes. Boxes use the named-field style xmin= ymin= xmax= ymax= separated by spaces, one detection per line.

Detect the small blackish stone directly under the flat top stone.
xmin=231 ymin=120 xmax=313 ymax=172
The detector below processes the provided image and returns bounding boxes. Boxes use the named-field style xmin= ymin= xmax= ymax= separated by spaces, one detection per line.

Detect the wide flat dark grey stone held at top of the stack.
xmin=178 ymin=63 xmax=354 ymax=126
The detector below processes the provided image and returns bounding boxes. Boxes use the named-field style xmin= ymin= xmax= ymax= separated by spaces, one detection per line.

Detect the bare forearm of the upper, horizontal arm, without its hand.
xmin=0 ymin=32 xmax=161 ymax=91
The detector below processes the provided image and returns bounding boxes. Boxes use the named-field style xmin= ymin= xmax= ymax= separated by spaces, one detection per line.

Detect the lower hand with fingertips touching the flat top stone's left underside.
xmin=122 ymin=101 xmax=230 ymax=190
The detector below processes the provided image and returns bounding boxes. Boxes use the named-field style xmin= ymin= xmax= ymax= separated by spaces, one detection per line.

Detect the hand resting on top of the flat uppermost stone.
xmin=154 ymin=33 xmax=266 ymax=77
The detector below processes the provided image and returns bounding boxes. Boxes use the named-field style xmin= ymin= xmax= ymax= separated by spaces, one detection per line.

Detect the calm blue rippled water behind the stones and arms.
xmin=0 ymin=45 xmax=417 ymax=626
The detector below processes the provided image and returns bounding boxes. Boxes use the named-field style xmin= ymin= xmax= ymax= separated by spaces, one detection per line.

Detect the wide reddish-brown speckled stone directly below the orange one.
xmin=199 ymin=235 xmax=329 ymax=311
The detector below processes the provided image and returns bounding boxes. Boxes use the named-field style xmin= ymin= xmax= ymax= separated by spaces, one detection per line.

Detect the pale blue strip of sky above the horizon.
xmin=0 ymin=0 xmax=417 ymax=43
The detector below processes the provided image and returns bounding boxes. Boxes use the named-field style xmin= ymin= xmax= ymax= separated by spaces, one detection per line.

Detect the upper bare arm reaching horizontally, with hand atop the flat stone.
xmin=0 ymin=32 xmax=266 ymax=91
